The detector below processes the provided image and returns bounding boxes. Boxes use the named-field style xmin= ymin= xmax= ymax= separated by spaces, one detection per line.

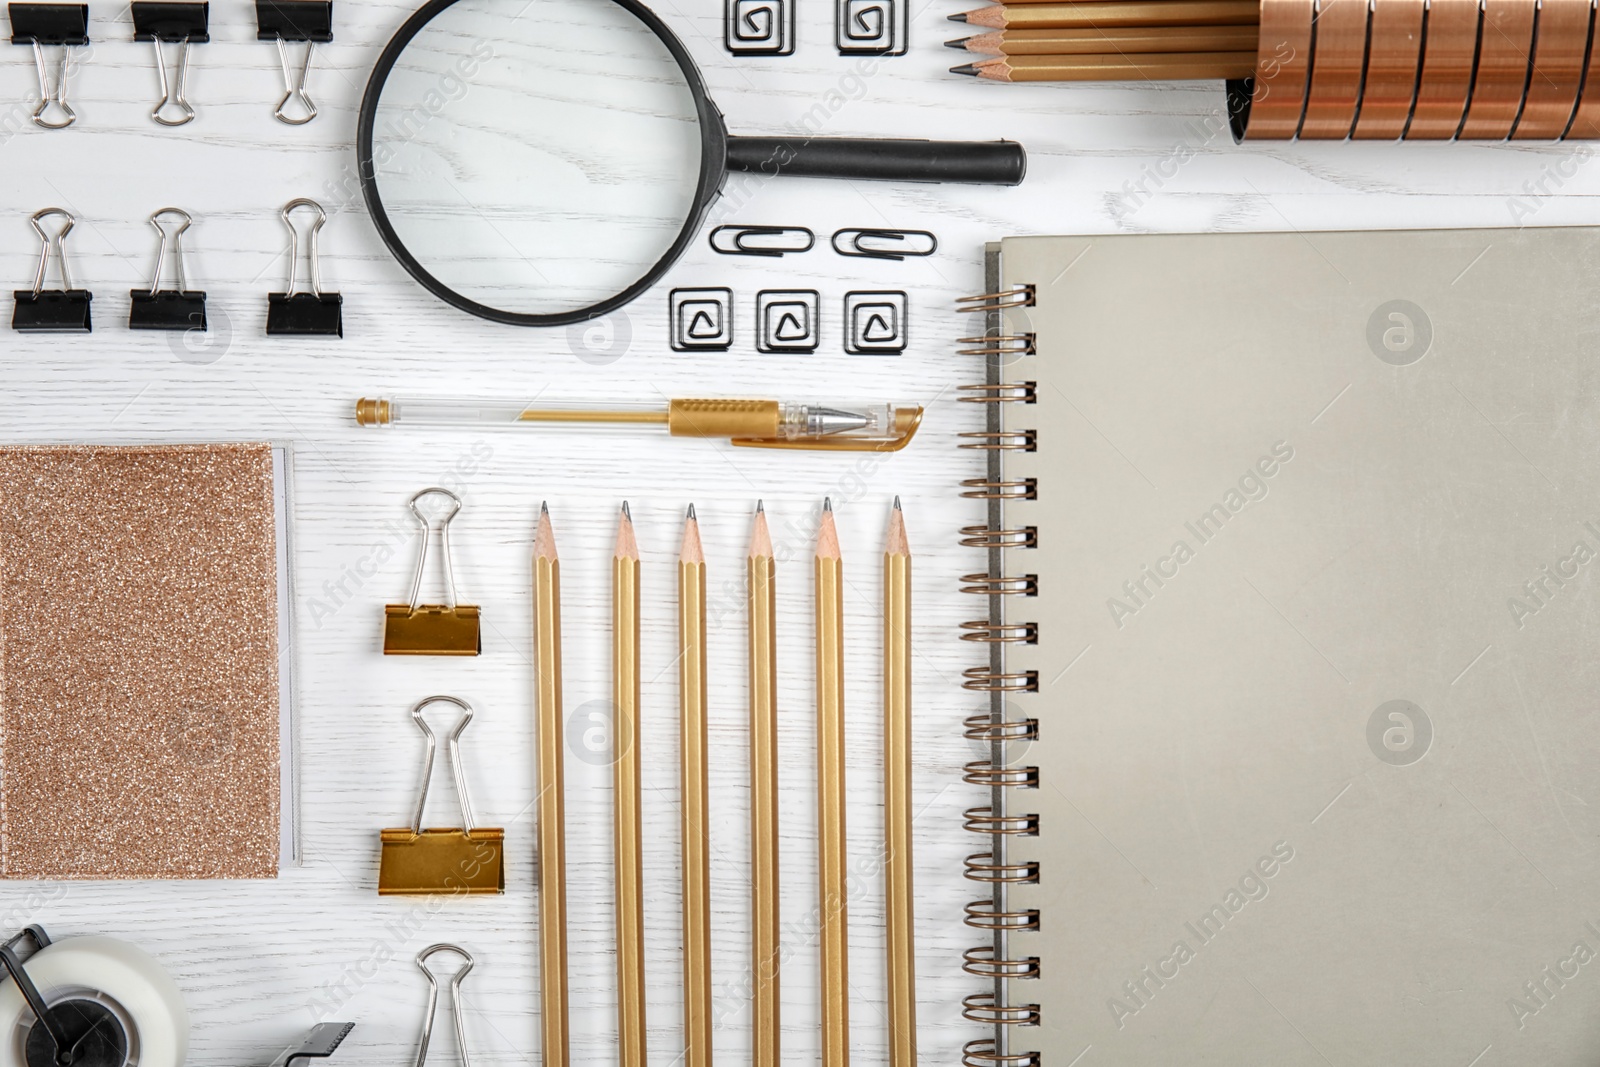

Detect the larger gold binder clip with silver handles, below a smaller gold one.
xmin=378 ymin=696 xmax=506 ymax=896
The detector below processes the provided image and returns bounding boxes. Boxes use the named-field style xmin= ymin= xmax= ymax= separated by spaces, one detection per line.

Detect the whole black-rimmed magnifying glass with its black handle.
xmin=357 ymin=0 xmax=1027 ymax=326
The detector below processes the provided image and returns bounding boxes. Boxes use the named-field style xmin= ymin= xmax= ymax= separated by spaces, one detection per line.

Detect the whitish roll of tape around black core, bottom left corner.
xmin=0 ymin=936 xmax=189 ymax=1067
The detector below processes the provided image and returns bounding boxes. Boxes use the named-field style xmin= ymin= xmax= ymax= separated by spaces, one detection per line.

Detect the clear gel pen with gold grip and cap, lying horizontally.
xmin=355 ymin=397 xmax=922 ymax=453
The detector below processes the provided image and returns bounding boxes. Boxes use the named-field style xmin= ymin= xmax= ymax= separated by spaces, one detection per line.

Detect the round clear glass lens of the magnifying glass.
xmin=371 ymin=0 xmax=702 ymax=315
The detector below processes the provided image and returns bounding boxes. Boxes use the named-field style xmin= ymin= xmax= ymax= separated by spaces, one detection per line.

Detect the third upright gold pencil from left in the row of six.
xmin=678 ymin=504 xmax=712 ymax=1067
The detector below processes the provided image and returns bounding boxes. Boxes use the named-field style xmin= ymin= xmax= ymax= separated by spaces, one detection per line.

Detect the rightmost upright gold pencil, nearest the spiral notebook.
xmin=883 ymin=496 xmax=917 ymax=1067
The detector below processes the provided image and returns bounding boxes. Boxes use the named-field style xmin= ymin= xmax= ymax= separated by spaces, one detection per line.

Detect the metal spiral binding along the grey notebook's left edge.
xmin=958 ymin=278 xmax=1042 ymax=1067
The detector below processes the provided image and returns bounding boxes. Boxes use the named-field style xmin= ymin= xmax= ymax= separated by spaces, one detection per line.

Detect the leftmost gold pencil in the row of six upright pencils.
xmin=533 ymin=504 xmax=568 ymax=1067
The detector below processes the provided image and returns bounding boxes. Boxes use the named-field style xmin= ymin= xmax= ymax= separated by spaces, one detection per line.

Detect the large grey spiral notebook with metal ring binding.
xmin=966 ymin=229 xmax=1600 ymax=1067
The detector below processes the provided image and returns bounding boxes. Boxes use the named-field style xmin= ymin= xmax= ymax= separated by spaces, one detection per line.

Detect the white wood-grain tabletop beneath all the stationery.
xmin=0 ymin=0 xmax=1600 ymax=1067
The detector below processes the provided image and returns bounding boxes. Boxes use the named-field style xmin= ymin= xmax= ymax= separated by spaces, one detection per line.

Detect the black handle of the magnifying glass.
xmin=728 ymin=136 xmax=1027 ymax=186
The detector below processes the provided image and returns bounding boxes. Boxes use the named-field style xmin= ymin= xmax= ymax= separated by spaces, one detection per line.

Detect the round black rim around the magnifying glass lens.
xmin=355 ymin=0 xmax=728 ymax=326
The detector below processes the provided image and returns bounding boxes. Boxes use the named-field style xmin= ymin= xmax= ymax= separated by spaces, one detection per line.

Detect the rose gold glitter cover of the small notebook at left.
xmin=0 ymin=445 xmax=280 ymax=878
